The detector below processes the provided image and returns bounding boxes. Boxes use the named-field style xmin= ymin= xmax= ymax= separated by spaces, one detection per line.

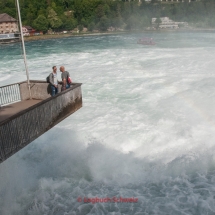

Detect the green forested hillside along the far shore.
xmin=0 ymin=0 xmax=215 ymax=32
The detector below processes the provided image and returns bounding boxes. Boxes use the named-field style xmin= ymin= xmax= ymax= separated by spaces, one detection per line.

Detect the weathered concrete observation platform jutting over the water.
xmin=0 ymin=80 xmax=82 ymax=163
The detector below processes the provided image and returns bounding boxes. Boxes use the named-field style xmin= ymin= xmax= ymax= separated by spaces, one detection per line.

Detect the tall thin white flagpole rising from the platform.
xmin=16 ymin=0 xmax=32 ymax=99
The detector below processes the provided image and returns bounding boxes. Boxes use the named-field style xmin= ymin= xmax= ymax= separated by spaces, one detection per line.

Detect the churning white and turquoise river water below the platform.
xmin=0 ymin=32 xmax=215 ymax=215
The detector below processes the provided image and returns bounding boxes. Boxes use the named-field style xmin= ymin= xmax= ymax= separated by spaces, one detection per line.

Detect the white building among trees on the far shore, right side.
xmin=152 ymin=17 xmax=188 ymax=29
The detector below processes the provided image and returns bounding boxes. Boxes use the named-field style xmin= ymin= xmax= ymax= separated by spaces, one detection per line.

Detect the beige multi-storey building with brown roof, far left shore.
xmin=0 ymin=13 xmax=19 ymax=34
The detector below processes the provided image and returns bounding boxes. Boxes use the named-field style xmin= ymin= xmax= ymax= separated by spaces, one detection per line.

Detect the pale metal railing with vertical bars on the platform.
xmin=0 ymin=84 xmax=21 ymax=105
